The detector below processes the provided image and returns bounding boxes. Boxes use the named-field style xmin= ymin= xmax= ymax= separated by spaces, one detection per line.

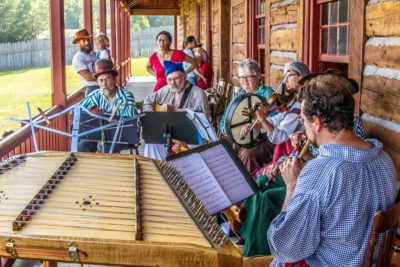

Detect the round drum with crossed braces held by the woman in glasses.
xmin=224 ymin=94 xmax=265 ymax=147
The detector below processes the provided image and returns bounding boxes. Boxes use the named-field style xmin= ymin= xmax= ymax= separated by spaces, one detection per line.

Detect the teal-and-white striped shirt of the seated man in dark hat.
xmin=80 ymin=87 xmax=137 ymax=117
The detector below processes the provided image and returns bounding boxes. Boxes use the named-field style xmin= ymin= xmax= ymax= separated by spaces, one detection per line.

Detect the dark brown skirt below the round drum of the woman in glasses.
xmin=238 ymin=141 xmax=275 ymax=174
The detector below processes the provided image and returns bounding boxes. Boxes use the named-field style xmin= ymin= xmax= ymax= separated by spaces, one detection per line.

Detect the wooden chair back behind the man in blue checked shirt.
xmin=364 ymin=195 xmax=400 ymax=267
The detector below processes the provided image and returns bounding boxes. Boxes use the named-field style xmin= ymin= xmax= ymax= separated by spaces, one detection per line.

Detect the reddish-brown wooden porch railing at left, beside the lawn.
xmin=0 ymin=89 xmax=84 ymax=160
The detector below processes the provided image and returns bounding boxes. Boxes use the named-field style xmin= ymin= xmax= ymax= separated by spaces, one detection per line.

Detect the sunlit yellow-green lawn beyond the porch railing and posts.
xmin=0 ymin=57 xmax=150 ymax=135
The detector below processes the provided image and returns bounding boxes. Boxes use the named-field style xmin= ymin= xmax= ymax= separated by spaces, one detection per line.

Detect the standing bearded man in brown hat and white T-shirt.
xmin=72 ymin=29 xmax=100 ymax=95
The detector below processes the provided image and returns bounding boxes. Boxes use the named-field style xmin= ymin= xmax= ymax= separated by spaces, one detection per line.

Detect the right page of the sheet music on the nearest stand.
xmin=200 ymin=145 xmax=254 ymax=204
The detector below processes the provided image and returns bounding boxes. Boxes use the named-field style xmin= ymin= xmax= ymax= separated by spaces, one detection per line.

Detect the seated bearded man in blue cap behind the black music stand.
xmin=143 ymin=60 xmax=208 ymax=159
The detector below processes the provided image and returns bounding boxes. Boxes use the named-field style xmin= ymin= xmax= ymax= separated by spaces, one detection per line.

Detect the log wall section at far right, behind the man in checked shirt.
xmin=361 ymin=0 xmax=400 ymax=180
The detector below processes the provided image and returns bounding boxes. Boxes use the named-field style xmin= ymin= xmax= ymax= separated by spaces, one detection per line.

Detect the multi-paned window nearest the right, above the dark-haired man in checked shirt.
xmin=319 ymin=0 xmax=349 ymax=63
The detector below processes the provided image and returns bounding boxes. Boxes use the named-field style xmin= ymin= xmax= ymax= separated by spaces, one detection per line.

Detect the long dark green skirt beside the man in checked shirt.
xmin=239 ymin=175 xmax=286 ymax=257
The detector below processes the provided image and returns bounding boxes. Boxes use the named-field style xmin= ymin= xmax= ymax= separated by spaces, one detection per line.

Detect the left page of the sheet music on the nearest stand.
xmin=172 ymin=153 xmax=232 ymax=214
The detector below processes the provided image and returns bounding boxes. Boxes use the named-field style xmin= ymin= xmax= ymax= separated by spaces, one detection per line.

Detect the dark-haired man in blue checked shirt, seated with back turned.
xmin=267 ymin=74 xmax=398 ymax=266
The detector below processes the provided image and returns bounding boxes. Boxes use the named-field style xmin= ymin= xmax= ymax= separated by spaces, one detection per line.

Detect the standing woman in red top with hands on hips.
xmin=146 ymin=31 xmax=197 ymax=92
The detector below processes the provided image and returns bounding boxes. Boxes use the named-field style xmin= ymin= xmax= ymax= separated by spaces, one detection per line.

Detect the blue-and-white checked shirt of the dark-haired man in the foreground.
xmin=267 ymin=139 xmax=398 ymax=266
